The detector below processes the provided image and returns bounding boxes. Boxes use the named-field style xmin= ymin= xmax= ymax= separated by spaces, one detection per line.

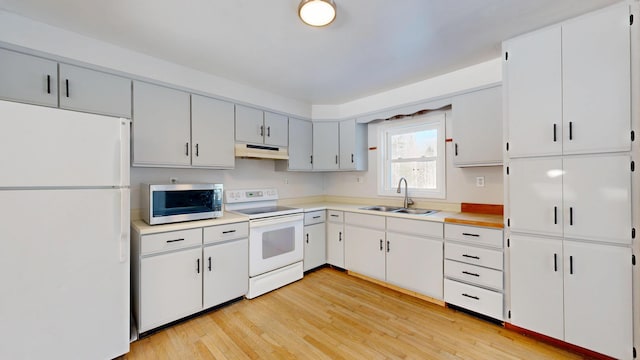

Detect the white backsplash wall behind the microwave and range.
xmin=131 ymin=159 xmax=324 ymax=209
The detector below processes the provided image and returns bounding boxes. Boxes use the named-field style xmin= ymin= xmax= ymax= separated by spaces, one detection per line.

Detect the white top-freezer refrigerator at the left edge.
xmin=0 ymin=101 xmax=130 ymax=360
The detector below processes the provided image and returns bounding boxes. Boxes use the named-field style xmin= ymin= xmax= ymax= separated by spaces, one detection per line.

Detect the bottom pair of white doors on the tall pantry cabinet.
xmin=510 ymin=234 xmax=633 ymax=359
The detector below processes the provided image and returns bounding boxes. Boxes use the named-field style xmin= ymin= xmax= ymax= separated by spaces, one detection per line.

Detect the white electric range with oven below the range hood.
xmin=225 ymin=188 xmax=304 ymax=299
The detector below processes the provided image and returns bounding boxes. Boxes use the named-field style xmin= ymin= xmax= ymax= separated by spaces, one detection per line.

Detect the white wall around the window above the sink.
xmin=325 ymin=111 xmax=504 ymax=205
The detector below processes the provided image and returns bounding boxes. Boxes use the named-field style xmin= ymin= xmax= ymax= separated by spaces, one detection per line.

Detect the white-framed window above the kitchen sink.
xmin=378 ymin=113 xmax=446 ymax=199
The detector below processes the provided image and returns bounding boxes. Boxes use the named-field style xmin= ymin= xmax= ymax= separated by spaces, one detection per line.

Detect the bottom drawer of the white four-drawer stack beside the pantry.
xmin=444 ymin=279 xmax=503 ymax=320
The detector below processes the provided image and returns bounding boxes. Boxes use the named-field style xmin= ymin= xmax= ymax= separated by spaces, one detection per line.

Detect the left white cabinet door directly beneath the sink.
xmin=344 ymin=225 xmax=386 ymax=281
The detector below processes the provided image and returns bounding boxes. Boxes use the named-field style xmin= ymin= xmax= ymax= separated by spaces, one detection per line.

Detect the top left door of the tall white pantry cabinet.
xmin=503 ymin=26 xmax=564 ymax=157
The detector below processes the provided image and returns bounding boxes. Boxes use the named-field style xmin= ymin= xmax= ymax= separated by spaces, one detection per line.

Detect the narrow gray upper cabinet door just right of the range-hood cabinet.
xmin=289 ymin=118 xmax=313 ymax=170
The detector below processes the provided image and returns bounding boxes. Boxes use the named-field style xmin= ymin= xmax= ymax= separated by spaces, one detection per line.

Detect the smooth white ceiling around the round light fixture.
xmin=0 ymin=0 xmax=618 ymax=104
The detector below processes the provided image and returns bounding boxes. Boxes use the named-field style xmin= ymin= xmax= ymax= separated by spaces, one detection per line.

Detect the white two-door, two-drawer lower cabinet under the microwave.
xmin=131 ymin=222 xmax=249 ymax=333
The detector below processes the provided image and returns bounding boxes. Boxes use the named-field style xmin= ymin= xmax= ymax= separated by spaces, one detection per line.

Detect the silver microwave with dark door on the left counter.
xmin=141 ymin=184 xmax=223 ymax=225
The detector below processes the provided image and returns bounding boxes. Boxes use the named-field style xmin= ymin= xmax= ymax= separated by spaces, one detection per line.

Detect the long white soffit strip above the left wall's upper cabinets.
xmin=0 ymin=10 xmax=311 ymax=118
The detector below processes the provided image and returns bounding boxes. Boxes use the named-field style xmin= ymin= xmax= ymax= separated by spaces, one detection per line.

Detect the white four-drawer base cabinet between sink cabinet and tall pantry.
xmin=444 ymin=224 xmax=504 ymax=320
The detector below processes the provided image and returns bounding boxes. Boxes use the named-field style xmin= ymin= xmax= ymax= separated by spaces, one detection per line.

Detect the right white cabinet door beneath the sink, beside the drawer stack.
xmin=386 ymin=232 xmax=444 ymax=299
